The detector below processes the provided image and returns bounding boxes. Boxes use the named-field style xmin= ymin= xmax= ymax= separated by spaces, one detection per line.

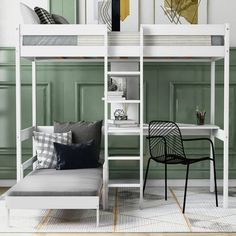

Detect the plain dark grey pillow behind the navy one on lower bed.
xmin=54 ymin=120 xmax=102 ymax=160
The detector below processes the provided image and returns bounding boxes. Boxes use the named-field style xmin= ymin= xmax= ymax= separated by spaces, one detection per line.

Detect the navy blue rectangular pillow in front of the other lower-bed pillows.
xmin=54 ymin=140 xmax=100 ymax=170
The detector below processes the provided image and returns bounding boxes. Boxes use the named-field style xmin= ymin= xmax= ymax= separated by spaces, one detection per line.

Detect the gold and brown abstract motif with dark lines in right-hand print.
xmin=162 ymin=0 xmax=201 ymax=24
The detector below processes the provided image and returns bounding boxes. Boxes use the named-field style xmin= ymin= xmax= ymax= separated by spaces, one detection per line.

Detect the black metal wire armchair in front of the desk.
xmin=143 ymin=121 xmax=218 ymax=213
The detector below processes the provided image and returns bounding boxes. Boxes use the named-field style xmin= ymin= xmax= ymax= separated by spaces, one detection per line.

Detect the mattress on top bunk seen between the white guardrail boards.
xmin=23 ymin=32 xmax=224 ymax=46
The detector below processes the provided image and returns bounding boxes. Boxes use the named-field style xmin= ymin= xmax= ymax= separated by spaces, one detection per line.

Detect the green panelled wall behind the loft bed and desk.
xmin=0 ymin=48 xmax=236 ymax=179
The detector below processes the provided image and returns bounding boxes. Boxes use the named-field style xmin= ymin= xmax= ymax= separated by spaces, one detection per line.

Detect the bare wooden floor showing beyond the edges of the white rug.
xmin=0 ymin=187 xmax=236 ymax=236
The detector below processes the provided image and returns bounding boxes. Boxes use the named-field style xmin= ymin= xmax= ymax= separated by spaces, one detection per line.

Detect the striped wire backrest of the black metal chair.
xmin=148 ymin=121 xmax=186 ymax=158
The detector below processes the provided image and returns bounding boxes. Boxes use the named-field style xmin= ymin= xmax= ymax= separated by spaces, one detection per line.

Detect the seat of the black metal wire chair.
xmin=151 ymin=155 xmax=211 ymax=165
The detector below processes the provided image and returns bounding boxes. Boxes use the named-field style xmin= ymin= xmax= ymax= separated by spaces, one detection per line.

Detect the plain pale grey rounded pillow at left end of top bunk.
xmin=20 ymin=2 xmax=40 ymax=24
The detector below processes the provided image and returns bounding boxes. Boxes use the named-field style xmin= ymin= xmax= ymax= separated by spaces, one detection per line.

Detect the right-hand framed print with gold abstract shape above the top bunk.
xmin=154 ymin=0 xmax=207 ymax=24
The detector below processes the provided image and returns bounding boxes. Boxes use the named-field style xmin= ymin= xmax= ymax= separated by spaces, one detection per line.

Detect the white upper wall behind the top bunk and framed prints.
xmin=0 ymin=0 xmax=236 ymax=47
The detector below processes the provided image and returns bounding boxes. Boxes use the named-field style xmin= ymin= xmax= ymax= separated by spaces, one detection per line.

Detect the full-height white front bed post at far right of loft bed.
xmin=223 ymin=24 xmax=229 ymax=208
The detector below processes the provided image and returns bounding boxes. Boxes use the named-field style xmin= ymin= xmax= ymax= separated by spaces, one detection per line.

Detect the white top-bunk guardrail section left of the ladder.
xmin=19 ymin=24 xmax=107 ymax=58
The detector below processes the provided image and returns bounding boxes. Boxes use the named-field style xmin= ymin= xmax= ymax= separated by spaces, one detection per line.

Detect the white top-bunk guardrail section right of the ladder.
xmin=141 ymin=24 xmax=229 ymax=58
